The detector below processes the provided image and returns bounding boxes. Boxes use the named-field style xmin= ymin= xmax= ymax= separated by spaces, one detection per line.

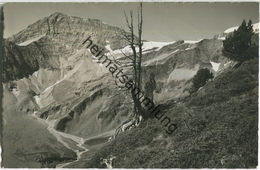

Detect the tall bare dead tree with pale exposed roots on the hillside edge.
xmin=112 ymin=3 xmax=145 ymax=136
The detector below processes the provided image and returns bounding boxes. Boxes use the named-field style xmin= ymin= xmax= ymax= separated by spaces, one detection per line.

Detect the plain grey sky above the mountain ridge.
xmin=4 ymin=2 xmax=259 ymax=42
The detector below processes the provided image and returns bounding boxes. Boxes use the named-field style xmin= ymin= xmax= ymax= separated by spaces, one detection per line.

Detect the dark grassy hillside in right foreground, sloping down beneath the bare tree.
xmin=80 ymin=59 xmax=258 ymax=168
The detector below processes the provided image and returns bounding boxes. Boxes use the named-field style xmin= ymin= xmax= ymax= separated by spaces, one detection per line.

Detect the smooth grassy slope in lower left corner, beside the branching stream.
xmin=2 ymin=89 xmax=76 ymax=168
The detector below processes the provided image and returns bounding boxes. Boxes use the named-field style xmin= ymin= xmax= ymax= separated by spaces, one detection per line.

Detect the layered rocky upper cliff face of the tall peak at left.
xmin=4 ymin=13 xmax=129 ymax=81
